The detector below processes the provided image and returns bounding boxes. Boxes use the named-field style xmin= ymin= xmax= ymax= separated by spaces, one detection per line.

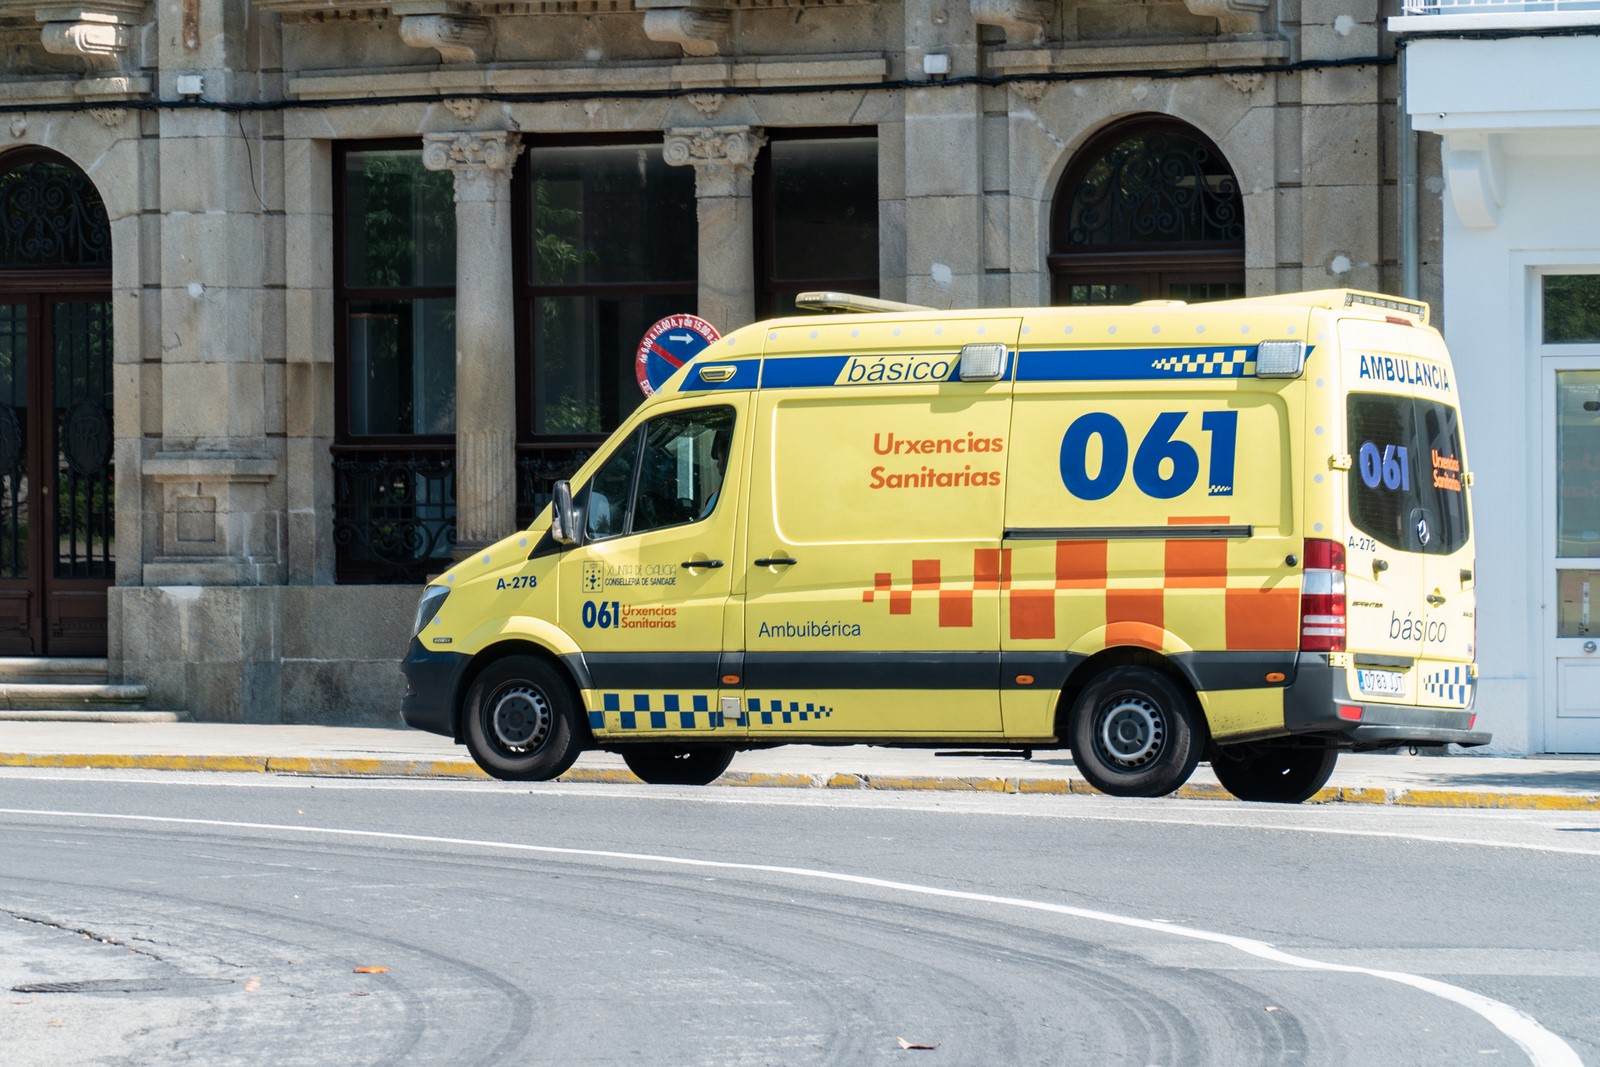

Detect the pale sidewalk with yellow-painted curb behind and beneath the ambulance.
xmin=9 ymin=720 xmax=1600 ymax=811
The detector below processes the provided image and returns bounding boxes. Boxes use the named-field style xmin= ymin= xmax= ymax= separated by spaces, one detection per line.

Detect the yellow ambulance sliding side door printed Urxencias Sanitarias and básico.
xmin=744 ymin=315 xmax=1019 ymax=739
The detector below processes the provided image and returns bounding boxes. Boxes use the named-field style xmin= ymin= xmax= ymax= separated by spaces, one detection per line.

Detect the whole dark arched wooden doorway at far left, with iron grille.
xmin=0 ymin=149 xmax=115 ymax=656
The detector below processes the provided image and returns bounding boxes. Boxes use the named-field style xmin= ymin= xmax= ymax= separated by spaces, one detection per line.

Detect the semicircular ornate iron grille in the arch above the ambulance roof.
xmin=1067 ymin=131 xmax=1245 ymax=248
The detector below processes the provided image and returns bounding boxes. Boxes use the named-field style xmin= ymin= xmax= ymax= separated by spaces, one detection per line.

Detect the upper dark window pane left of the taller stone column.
xmin=344 ymin=149 xmax=456 ymax=290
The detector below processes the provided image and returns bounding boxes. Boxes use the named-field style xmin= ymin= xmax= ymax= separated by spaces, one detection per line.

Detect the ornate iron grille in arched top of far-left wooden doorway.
xmin=0 ymin=160 xmax=110 ymax=267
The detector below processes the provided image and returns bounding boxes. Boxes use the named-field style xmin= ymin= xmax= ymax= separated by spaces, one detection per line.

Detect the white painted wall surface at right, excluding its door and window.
xmin=1390 ymin=29 xmax=1600 ymax=753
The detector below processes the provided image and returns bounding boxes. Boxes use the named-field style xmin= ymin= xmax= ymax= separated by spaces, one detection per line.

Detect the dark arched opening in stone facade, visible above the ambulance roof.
xmin=1050 ymin=115 xmax=1245 ymax=304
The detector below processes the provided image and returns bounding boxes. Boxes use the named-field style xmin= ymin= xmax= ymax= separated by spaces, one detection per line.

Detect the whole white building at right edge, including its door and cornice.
xmin=1389 ymin=0 xmax=1600 ymax=752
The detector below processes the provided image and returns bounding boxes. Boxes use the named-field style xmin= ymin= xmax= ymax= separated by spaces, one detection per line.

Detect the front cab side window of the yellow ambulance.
xmin=582 ymin=406 xmax=734 ymax=541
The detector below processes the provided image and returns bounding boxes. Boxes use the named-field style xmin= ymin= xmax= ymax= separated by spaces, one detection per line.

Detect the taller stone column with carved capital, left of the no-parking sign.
xmin=422 ymin=131 xmax=522 ymax=555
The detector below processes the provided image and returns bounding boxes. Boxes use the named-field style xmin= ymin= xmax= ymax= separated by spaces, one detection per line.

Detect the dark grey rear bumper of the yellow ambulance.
xmin=1283 ymin=653 xmax=1493 ymax=749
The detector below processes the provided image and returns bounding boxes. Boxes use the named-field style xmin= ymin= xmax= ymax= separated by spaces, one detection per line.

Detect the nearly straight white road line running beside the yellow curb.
xmin=0 ymin=768 xmax=1600 ymax=857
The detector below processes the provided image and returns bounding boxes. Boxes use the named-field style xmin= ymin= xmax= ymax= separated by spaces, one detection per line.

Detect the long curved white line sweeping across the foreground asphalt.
xmin=0 ymin=808 xmax=1582 ymax=1067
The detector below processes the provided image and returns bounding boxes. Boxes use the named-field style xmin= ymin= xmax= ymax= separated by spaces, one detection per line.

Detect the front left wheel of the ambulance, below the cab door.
xmin=462 ymin=656 xmax=587 ymax=782
